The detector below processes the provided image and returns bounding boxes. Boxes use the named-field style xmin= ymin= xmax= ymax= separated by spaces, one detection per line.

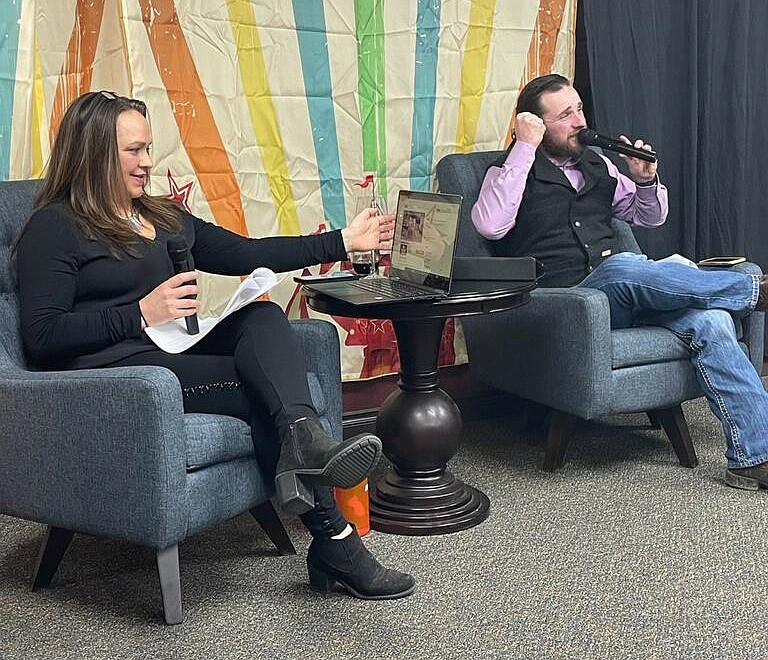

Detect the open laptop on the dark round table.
xmin=304 ymin=190 xmax=461 ymax=305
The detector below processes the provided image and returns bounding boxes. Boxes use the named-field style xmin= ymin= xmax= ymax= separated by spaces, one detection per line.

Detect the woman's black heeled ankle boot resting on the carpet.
xmin=307 ymin=525 xmax=416 ymax=600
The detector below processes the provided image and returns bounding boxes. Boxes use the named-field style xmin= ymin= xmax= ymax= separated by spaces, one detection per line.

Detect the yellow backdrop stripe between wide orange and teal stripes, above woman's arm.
xmin=227 ymin=0 xmax=300 ymax=234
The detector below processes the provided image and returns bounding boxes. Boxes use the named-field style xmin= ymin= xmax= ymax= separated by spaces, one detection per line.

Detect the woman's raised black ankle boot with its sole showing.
xmin=275 ymin=417 xmax=381 ymax=515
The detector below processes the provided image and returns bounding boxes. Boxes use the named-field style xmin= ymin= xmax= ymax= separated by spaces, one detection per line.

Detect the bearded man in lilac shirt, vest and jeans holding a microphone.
xmin=472 ymin=74 xmax=768 ymax=490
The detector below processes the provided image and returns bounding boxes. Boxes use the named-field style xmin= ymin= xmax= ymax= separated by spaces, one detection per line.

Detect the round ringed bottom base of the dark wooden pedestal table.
xmin=370 ymin=469 xmax=490 ymax=536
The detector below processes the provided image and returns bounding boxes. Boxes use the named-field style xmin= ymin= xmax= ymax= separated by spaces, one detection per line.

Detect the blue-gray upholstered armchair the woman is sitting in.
xmin=0 ymin=181 xmax=341 ymax=623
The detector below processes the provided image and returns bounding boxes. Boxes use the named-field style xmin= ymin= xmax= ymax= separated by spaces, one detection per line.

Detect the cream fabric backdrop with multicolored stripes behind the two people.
xmin=0 ymin=0 xmax=576 ymax=379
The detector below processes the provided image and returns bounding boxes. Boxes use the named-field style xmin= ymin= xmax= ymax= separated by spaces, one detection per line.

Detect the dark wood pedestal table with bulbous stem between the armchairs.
xmin=304 ymin=281 xmax=535 ymax=536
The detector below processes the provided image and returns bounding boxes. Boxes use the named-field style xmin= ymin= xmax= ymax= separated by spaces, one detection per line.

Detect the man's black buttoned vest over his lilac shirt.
xmin=491 ymin=149 xmax=616 ymax=286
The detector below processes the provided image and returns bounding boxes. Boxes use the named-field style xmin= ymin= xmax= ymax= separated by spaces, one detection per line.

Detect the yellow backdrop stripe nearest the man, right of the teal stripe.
xmin=456 ymin=0 xmax=496 ymax=151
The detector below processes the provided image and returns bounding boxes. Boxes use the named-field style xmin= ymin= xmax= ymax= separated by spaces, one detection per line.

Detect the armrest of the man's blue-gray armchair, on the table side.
xmin=462 ymin=288 xmax=611 ymax=419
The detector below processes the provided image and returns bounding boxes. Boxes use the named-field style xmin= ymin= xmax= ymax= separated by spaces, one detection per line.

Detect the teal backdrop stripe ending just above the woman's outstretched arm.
xmin=293 ymin=0 xmax=347 ymax=229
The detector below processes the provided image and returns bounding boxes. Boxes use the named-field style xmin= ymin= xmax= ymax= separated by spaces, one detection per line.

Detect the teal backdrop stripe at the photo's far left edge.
xmin=0 ymin=0 xmax=22 ymax=181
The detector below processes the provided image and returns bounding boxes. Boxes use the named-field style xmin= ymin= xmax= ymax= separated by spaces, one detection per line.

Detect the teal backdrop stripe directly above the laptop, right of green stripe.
xmin=411 ymin=0 xmax=441 ymax=190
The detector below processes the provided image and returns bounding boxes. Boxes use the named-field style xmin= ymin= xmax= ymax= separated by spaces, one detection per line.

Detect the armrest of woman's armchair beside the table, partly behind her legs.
xmin=291 ymin=319 xmax=342 ymax=440
